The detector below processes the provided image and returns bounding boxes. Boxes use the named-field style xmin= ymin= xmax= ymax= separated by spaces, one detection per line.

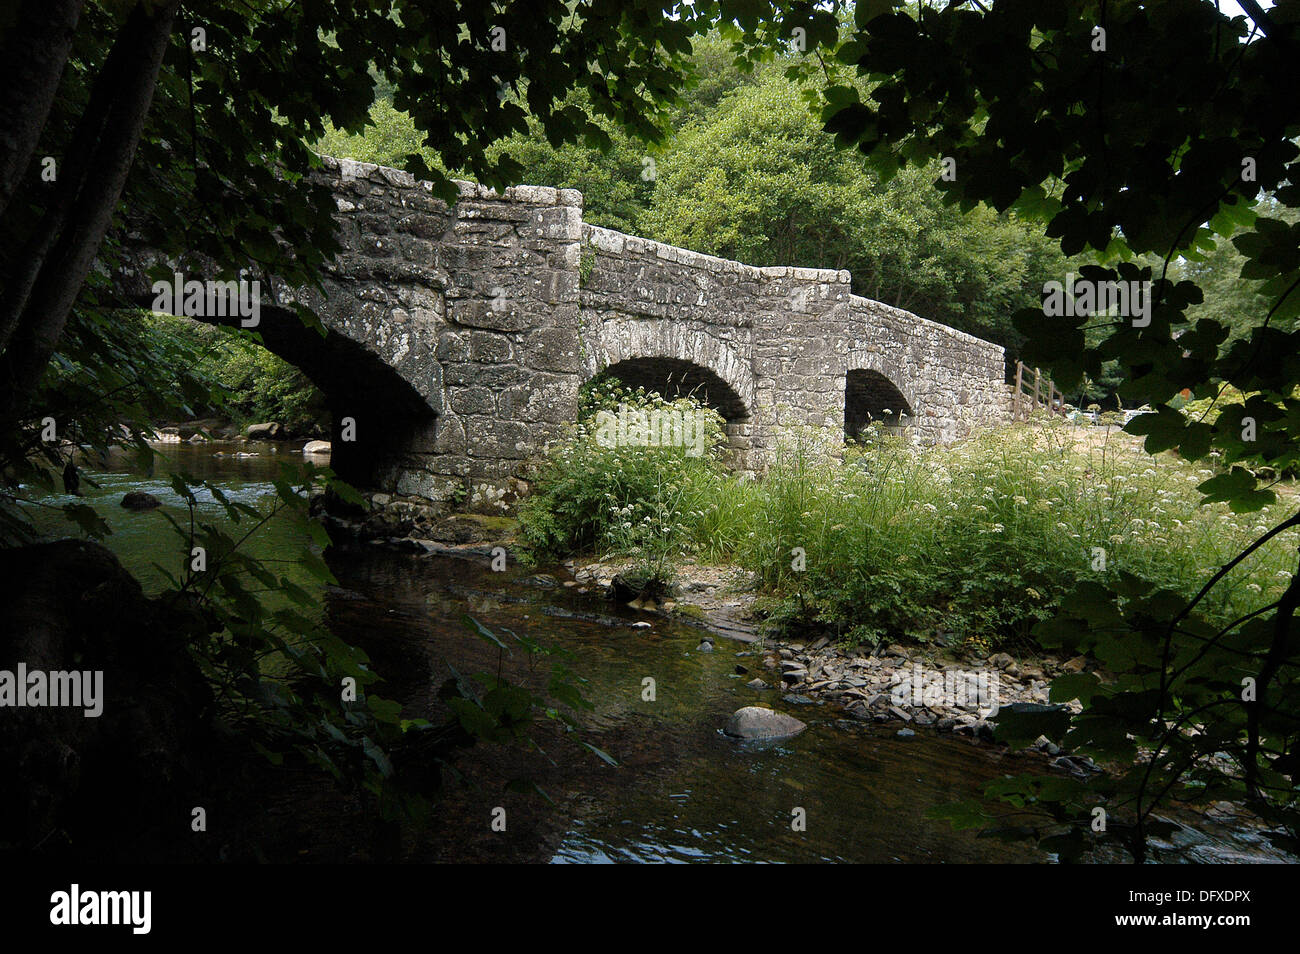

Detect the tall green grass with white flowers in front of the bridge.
xmin=525 ymin=395 xmax=1300 ymax=649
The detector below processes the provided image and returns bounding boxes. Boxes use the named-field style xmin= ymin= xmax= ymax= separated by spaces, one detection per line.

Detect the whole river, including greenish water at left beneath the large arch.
xmin=30 ymin=445 xmax=1289 ymax=863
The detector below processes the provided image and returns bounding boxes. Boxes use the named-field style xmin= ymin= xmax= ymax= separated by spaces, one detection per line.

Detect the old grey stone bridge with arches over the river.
xmin=122 ymin=159 xmax=1008 ymax=508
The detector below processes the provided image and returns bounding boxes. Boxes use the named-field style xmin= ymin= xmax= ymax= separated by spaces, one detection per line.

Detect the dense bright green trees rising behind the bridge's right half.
xmin=642 ymin=73 xmax=1065 ymax=355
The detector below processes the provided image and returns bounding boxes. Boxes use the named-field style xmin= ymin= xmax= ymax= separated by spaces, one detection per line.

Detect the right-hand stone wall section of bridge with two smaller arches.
xmin=580 ymin=217 xmax=1008 ymax=469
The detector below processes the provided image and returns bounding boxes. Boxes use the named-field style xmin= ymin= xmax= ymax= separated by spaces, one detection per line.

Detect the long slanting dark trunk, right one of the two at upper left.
xmin=0 ymin=3 xmax=178 ymax=422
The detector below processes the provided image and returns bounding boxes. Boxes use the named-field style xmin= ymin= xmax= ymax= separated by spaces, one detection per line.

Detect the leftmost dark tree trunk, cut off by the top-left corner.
xmin=0 ymin=0 xmax=82 ymax=214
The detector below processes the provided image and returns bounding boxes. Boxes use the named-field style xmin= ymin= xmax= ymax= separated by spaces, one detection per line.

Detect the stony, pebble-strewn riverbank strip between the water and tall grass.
xmin=334 ymin=495 xmax=1092 ymax=775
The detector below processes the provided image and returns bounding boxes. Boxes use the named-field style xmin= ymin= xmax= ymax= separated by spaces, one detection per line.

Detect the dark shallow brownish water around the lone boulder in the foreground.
xmin=330 ymin=551 xmax=1031 ymax=862
